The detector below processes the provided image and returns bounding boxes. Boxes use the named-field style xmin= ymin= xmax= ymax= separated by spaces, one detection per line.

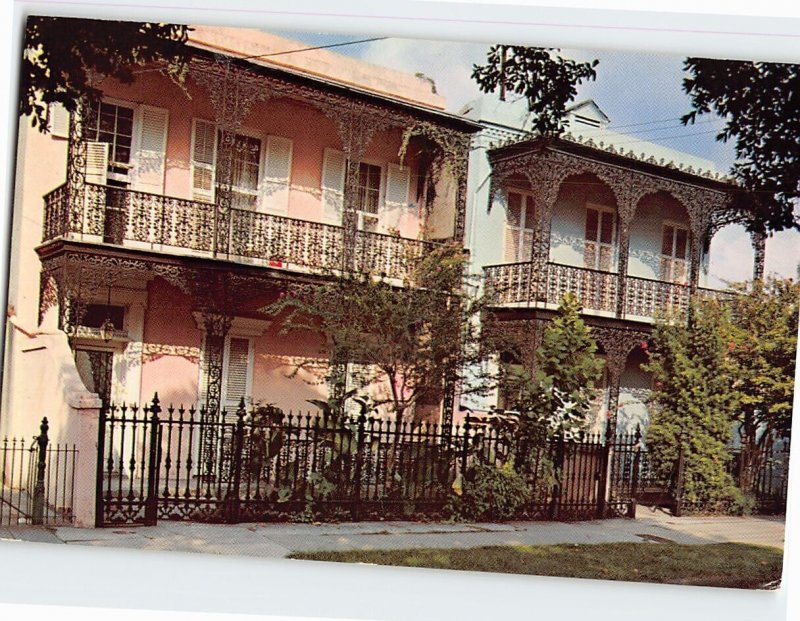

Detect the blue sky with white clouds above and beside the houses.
xmin=276 ymin=27 xmax=800 ymax=286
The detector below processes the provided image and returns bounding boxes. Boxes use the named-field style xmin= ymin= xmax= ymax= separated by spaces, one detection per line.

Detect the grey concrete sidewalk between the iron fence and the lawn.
xmin=0 ymin=507 xmax=784 ymax=558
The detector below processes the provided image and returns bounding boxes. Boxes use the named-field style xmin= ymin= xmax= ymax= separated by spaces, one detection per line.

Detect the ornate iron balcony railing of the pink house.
xmin=43 ymin=183 xmax=435 ymax=280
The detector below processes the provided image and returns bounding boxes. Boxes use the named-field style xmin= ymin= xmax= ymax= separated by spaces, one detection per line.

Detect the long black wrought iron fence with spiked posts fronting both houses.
xmin=97 ymin=400 xmax=638 ymax=526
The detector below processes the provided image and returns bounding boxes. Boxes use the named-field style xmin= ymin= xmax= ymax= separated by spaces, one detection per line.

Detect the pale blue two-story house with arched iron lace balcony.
xmin=462 ymin=97 xmax=763 ymax=433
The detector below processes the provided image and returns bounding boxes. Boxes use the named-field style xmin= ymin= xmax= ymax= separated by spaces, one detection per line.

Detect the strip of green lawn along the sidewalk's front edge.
xmin=290 ymin=543 xmax=783 ymax=589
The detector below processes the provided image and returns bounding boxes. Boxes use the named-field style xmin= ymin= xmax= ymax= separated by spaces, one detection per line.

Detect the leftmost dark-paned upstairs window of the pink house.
xmin=87 ymin=101 xmax=133 ymax=185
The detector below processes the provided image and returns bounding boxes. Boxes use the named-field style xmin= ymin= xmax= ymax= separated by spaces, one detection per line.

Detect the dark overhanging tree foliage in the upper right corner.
xmin=682 ymin=58 xmax=800 ymax=231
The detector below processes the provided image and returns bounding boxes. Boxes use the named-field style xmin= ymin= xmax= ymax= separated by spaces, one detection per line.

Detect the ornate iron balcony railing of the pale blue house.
xmin=484 ymin=263 xmax=731 ymax=318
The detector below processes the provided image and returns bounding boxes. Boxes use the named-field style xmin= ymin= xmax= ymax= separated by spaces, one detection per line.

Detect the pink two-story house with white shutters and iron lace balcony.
xmin=6 ymin=27 xmax=478 ymax=436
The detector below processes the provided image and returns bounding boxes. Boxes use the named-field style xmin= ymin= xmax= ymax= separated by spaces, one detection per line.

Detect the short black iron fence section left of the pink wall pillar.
xmin=0 ymin=418 xmax=78 ymax=525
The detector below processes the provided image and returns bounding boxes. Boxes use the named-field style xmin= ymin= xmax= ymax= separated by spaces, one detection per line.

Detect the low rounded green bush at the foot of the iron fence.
xmin=450 ymin=462 xmax=530 ymax=521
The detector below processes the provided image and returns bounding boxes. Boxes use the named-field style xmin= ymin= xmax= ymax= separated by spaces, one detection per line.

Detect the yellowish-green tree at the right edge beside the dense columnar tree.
xmin=728 ymin=280 xmax=800 ymax=489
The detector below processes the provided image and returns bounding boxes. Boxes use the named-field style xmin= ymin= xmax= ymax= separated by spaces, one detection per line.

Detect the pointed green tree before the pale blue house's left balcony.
xmin=490 ymin=294 xmax=603 ymax=470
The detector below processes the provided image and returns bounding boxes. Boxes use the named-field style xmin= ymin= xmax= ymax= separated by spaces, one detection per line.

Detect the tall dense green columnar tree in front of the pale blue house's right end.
xmin=645 ymin=300 xmax=739 ymax=509
